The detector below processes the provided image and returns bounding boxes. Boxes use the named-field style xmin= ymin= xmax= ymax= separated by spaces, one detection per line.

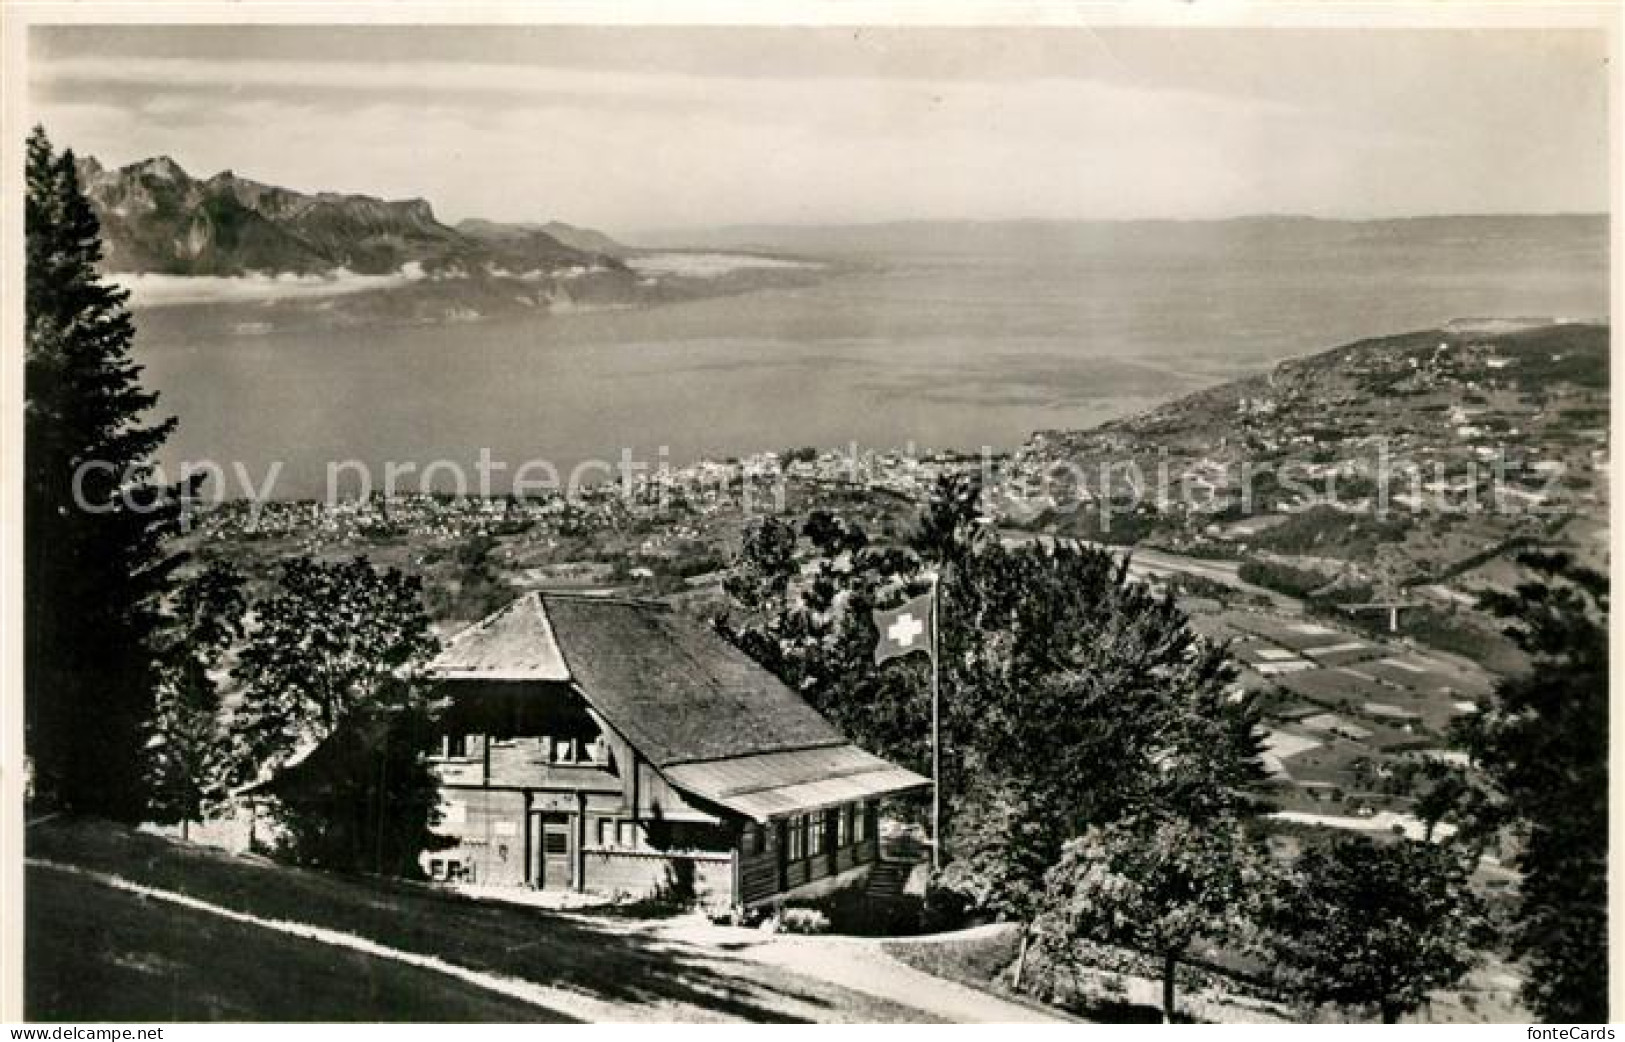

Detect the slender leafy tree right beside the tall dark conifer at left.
xmin=146 ymin=564 xmax=247 ymax=836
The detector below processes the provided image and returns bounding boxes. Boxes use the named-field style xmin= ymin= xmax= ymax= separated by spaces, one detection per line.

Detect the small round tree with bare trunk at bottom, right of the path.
xmin=1035 ymin=814 xmax=1264 ymax=1022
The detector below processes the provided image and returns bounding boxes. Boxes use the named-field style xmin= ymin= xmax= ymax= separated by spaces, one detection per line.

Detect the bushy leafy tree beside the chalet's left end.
xmin=232 ymin=558 xmax=436 ymax=784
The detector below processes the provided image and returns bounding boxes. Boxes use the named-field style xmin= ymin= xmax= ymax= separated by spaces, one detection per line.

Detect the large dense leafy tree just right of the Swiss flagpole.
xmin=941 ymin=543 xmax=1264 ymax=983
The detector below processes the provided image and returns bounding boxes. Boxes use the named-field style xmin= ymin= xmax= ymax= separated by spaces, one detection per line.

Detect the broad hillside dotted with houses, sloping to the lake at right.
xmin=1012 ymin=319 xmax=1610 ymax=671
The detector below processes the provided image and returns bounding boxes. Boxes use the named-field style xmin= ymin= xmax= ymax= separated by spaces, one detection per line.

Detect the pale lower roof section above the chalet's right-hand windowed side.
xmin=663 ymin=745 xmax=930 ymax=821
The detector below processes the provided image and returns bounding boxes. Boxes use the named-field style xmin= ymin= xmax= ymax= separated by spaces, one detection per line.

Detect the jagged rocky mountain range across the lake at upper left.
xmin=69 ymin=156 xmax=619 ymax=275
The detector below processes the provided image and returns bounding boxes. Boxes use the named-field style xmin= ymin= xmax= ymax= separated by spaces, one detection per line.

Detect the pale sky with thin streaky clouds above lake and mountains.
xmin=29 ymin=26 xmax=1609 ymax=234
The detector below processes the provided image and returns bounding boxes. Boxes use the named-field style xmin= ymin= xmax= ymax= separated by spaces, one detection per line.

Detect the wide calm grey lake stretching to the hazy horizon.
xmin=137 ymin=218 xmax=1609 ymax=496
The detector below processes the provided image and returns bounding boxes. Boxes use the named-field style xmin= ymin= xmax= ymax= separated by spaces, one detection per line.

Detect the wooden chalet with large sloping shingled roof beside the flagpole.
xmin=423 ymin=593 xmax=928 ymax=907
